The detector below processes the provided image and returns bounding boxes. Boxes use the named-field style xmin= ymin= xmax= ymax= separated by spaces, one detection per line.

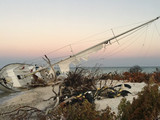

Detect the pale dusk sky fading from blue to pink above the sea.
xmin=0 ymin=0 xmax=160 ymax=68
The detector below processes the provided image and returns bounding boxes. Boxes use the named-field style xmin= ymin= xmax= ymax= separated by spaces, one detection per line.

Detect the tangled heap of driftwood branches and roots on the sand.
xmin=1 ymin=68 xmax=132 ymax=120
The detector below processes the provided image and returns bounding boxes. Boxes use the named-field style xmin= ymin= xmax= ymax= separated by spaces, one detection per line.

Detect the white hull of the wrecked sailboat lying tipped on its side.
xmin=0 ymin=63 xmax=54 ymax=92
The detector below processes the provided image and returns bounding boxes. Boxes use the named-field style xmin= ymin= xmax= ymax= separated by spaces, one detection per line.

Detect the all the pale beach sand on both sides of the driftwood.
xmin=0 ymin=82 xmax=145 ymax=120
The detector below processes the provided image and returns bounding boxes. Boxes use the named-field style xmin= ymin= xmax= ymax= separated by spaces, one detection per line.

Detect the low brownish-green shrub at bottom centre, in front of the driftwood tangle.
xmin=55 ymin=100 xmax=116 ymax=120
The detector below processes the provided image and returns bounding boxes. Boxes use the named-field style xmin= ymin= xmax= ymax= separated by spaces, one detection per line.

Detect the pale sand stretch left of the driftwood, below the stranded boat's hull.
xmin=0 ymin=86 xmax=57 ymax=120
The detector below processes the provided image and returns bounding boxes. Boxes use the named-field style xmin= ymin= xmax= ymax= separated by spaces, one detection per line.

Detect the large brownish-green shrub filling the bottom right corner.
xmin=118 ymin=85 xmax=160 ymax=120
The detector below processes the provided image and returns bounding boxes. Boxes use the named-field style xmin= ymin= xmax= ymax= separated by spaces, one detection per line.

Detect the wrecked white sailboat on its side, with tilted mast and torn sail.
xmin=0 ymin=17 xmax=159 ymax=91
